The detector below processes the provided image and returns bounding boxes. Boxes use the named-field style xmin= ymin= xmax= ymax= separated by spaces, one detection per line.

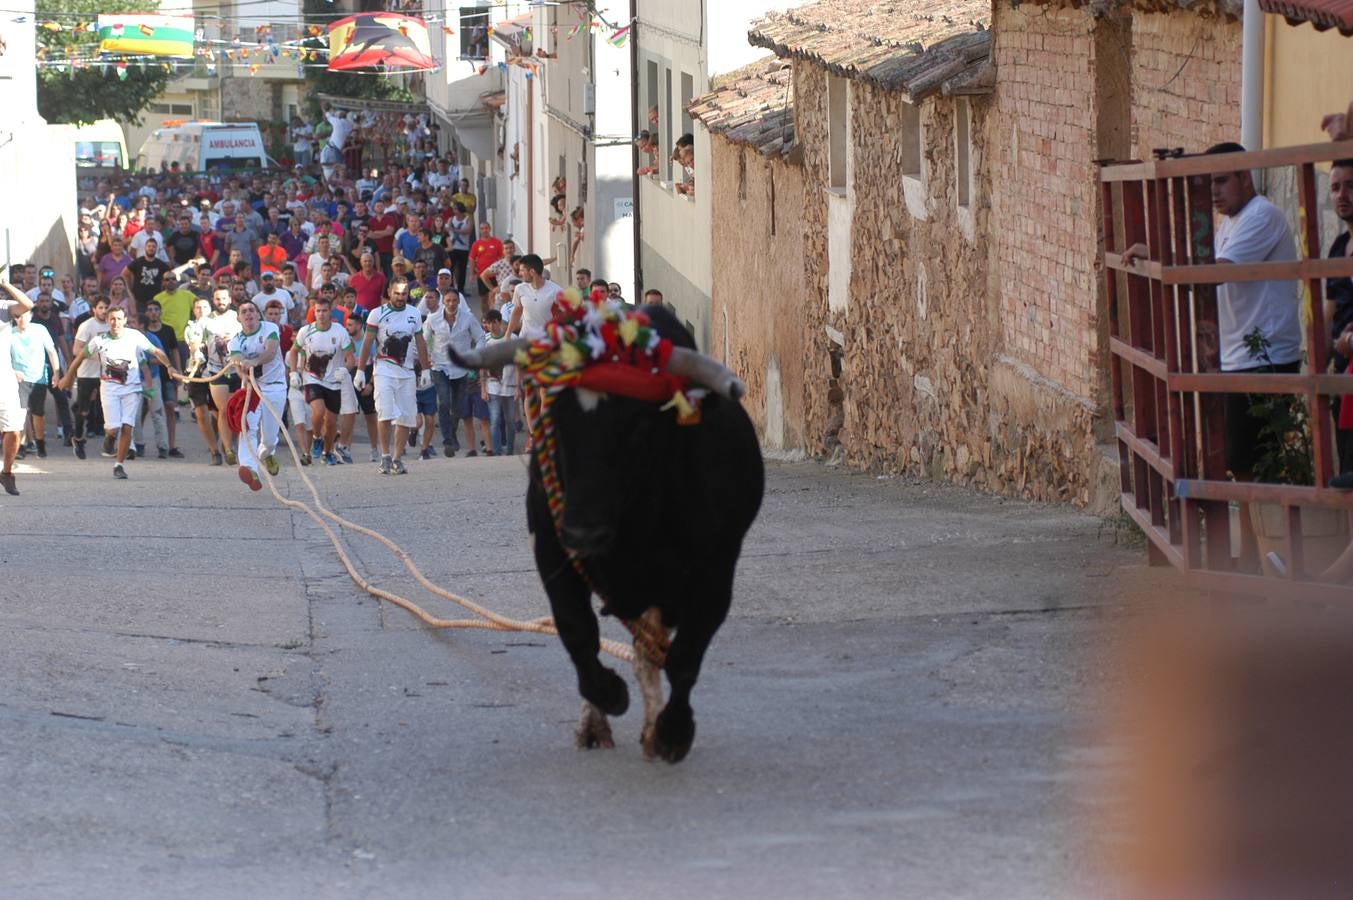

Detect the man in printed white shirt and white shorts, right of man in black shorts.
xmin=353 ymin=280 xmax=432 ymax=475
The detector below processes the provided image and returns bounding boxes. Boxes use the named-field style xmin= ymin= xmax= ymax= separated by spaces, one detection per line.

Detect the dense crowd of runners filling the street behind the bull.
xmin=0 ymin=110 xmax=662 ymax=494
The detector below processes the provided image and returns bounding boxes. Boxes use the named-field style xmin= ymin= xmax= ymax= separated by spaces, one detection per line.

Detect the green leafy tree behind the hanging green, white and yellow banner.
xmin=37 ymin=0 xmax=170 ymax=125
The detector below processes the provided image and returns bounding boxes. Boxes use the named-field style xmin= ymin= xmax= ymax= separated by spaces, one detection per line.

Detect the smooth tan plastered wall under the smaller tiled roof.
xmin=705 ymin=135 xmax=806 ymax=451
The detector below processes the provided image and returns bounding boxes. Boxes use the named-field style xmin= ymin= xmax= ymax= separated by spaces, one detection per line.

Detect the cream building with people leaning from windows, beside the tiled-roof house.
xmin=633 ymin=0 xmax=801 ymax=349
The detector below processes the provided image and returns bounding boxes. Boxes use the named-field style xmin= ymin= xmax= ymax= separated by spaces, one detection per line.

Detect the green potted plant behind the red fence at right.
xmin=1245 ymin=328 xmax=1349 ymax=577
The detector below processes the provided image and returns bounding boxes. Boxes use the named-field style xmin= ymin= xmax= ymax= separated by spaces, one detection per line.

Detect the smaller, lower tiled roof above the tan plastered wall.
xmin=689 ymin=57 xmax=794 ymax=156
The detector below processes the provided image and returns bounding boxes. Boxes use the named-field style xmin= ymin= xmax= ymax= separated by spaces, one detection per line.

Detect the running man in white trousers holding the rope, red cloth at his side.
xmin=230 ymin=300 xmax=287 ymax=491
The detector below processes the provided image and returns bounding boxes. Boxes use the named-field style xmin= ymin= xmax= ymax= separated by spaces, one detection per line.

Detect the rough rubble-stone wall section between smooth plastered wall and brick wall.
xmin=838 ymin=81 xmax=1000 ymax=486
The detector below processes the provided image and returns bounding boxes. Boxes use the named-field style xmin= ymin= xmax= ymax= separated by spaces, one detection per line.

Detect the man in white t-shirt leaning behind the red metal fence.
xmin=1123 ymin=142 xmax=1302 ymax=482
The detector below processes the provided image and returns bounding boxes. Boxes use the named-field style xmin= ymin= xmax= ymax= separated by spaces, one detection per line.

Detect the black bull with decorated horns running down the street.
xmin=454 ymin=307 xmax=764 ymax=762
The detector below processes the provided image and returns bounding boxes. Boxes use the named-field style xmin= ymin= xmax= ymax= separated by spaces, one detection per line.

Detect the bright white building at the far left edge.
xmin=0 ymin=0 xmax=78 ymax=276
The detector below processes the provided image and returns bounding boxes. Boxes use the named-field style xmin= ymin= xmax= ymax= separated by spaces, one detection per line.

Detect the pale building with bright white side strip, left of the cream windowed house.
xmin=529 ymin=0 xmax=636 ymax=299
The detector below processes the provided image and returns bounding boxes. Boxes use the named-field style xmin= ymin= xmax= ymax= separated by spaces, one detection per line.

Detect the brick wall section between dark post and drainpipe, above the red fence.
xmin=1132 ymin=11 xmax=1241 ymax=160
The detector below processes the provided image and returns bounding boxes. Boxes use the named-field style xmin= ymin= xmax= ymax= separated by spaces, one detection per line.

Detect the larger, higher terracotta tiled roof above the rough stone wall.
xmin=747 ymin=0 xmax=992 ymax=102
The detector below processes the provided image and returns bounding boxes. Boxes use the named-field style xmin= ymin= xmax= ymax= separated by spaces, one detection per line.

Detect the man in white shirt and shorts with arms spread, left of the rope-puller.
xmin=61 ymin=309 xmax=180 ymax=478
